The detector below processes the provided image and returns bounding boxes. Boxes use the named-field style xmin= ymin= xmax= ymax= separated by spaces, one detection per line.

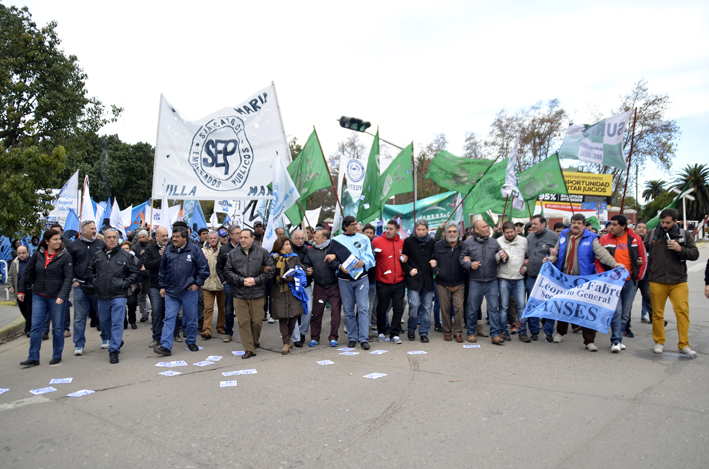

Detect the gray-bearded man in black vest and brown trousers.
xmin=433 ymin=222 xmax=465 ymax=343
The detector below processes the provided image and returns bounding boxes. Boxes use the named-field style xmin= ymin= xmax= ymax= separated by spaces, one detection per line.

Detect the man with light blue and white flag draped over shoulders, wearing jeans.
xmin=327 ymin=215 xmax=375 ymax=350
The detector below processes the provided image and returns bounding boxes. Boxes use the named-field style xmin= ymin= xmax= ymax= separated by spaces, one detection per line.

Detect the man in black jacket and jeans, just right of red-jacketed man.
xmin=403 ymin=218 xmax=438 ymax=343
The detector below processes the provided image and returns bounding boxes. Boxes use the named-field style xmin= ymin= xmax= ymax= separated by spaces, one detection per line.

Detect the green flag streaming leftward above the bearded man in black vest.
xmin=424 ymin=150 xmax=492 ymax=194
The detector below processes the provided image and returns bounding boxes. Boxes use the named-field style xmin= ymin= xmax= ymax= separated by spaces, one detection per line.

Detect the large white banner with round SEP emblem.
xmin=152 ymin=84 xmax=290 ymax=200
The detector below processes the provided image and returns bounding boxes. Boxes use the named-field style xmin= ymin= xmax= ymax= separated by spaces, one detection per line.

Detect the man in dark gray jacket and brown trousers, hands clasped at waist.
xmin=224 ymin=229 xmax=275 ymax=359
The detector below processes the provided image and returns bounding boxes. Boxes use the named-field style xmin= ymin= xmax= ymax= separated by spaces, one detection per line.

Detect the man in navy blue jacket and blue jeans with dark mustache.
xmin=153 ymin=226 xmax=209 ymax=356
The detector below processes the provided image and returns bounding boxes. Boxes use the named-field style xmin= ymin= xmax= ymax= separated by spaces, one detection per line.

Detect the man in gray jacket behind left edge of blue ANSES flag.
xmin=520 ymin=215 xmax=559 ymax=341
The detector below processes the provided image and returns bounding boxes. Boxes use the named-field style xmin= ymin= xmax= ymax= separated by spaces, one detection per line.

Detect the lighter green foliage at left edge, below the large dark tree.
xmin=0 ymin=146 xmax=65 ymax=236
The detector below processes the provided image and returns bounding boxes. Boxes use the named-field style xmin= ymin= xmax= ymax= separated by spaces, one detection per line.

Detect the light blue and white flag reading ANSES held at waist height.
xmin=522 ymin=262 xmax=629 ymax=334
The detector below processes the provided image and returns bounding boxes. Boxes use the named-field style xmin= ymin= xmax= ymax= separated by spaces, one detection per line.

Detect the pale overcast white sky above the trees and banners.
xmin=4 ymin=0 xmax=709 ymax=198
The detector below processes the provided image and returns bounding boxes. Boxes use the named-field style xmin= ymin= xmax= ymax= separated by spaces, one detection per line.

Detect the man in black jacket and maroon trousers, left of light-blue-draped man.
xmin=303 ymin=228 xmax=342 ymax=347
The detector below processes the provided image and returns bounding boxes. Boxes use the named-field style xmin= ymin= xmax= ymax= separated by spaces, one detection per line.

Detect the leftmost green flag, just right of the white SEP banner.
xmin=286 ymin=130 xmax=332 ymax=225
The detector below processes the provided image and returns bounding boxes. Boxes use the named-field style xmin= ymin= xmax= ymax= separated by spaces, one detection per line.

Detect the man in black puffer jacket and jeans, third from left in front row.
xmin=89 ymin=228 xmax=138 ymax=364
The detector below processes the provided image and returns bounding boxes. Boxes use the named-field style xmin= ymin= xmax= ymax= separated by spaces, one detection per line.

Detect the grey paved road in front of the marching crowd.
xmin=0 ymin=246 xmax=709 ymax=469
